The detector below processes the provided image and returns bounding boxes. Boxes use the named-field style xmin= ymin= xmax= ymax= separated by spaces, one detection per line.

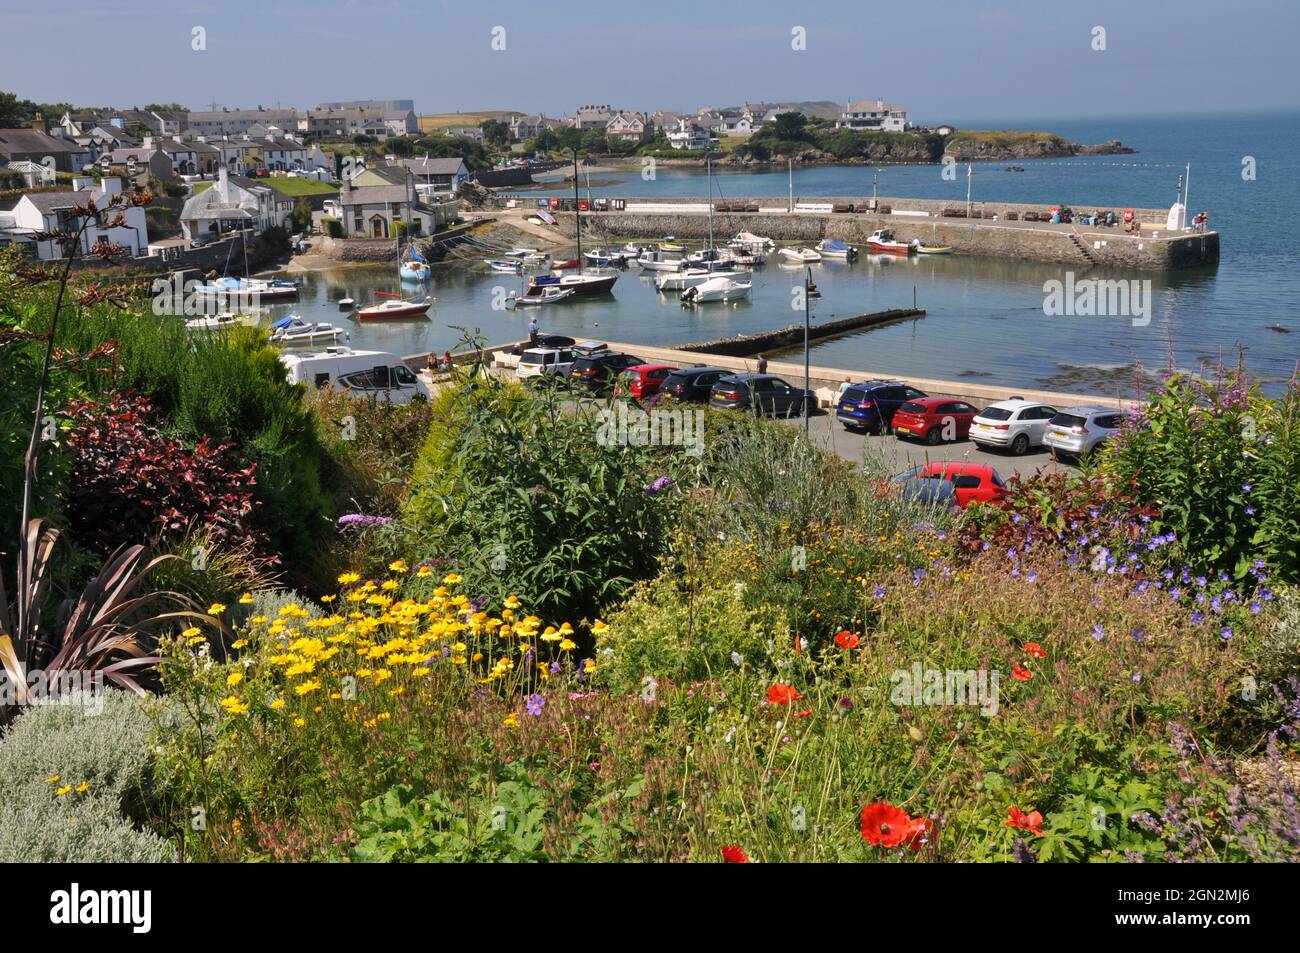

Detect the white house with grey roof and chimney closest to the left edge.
xmin=0 ymin=176 xmax=150 ymax=261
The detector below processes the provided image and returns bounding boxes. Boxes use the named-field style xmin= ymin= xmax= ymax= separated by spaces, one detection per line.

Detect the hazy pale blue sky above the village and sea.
xmin=0 ymin=0 xmax=1300 ymax=124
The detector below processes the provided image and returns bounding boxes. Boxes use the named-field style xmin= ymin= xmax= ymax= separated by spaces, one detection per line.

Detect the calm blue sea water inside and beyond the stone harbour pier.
xmin=263 ymin=113 xmax=1300 ymax=394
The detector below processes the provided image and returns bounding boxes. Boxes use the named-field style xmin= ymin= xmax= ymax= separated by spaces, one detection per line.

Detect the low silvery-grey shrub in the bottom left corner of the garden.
xmin=0 ymin=689 xmax=174 ymax=863
